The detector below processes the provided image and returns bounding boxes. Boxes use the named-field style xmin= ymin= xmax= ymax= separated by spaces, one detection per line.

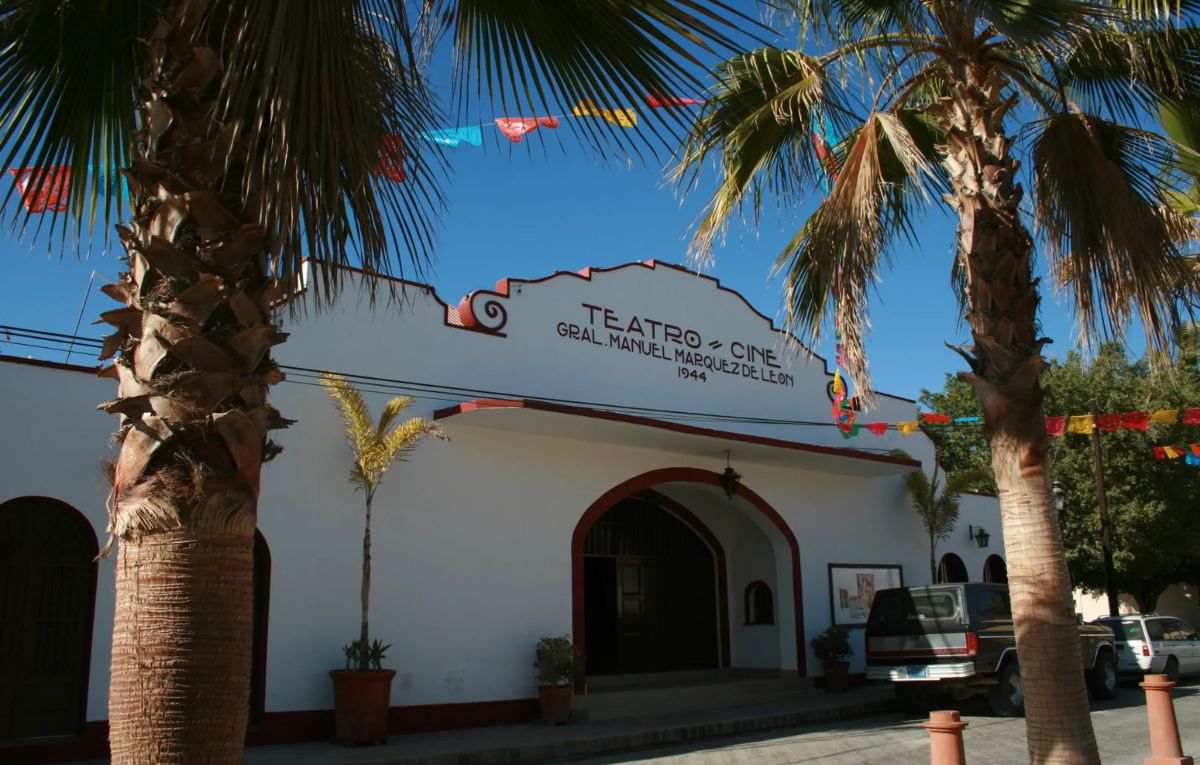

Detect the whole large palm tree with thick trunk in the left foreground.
xmin=0 ymin=0 xmax=745 ymax=764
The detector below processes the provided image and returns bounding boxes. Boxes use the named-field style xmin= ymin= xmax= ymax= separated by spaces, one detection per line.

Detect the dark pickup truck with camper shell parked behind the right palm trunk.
xmin=866 ymin=582 xmax=1118 ymax=717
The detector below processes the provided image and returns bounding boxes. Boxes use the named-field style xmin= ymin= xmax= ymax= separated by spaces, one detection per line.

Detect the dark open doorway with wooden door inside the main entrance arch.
xmin=583 ymin=498 xmax=720 ymax=675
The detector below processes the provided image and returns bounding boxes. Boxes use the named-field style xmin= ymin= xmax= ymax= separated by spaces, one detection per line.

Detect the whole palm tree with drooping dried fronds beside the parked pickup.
xmin=677 ymin=0 xmax=1200 ymax=763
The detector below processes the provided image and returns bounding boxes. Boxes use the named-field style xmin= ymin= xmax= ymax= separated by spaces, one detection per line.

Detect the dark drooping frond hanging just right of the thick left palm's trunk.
xmin=211 ymin=0 xmax=445 ymax=305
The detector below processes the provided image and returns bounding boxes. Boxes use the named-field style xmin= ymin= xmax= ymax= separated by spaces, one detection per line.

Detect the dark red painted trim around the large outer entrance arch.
xmin=571 ymin=468 xmax=808 ymax=693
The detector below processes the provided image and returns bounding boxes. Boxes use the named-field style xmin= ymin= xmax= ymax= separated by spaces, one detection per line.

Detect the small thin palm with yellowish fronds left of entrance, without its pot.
xmin=320 ymin=372 xmax=448 ymax=671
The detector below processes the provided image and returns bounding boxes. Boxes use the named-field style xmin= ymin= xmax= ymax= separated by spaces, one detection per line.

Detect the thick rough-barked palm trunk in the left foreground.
xmin=101 ymin=0 xmax=286 ymax=765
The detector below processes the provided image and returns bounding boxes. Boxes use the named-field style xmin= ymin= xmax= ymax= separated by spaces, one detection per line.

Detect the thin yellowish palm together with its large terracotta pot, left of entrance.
xmin=320 ymin=373 xmax=445 ymax=745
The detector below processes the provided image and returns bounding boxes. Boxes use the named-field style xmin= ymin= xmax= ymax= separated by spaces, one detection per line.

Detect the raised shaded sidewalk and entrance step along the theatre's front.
xmin=245 ymin=677 xmax=893 ymax=765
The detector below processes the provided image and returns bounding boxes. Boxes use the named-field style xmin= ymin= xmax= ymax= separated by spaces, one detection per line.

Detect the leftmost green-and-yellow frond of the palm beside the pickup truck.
xmin=673 ymin=48 xmax=846 ymax=263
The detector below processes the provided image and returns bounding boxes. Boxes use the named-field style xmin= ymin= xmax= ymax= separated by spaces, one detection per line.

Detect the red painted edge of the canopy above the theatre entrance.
xmin=433 ymin=398 xmax=920 ymax=468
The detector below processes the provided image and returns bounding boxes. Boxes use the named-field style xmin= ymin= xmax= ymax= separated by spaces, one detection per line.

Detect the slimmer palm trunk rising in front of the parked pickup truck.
xmin=940 ymin=61 xmax=1099 ymax=765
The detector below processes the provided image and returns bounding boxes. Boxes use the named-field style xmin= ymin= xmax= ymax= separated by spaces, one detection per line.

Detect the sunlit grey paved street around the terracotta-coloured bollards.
xmin=560 ymin=683 xmax=1200 ymax=765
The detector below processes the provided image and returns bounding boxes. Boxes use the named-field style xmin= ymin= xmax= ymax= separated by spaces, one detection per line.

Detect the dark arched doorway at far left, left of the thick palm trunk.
xmin=0 ymin=496 xmax=97 ymax=741
